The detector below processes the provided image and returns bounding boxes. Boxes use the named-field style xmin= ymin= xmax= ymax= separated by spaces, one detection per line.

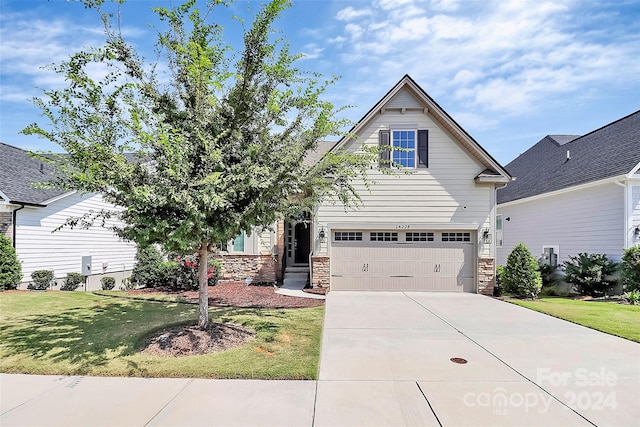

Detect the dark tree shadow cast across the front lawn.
xmin=0 ymin=298 xmax=286 ymax=375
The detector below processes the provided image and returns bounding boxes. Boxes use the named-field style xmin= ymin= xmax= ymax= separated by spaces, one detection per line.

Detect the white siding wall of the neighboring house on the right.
xmin=496 ymin=182 xmax=625 ymax=265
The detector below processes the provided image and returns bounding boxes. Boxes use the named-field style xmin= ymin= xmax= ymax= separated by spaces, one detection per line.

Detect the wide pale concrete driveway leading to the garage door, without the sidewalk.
xmin=314 ymin=292 xmax=640 ymax=427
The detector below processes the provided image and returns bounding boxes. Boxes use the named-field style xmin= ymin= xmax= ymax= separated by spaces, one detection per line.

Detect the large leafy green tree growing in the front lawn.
xmin=23 ymin=0 xmax=373 ymax=328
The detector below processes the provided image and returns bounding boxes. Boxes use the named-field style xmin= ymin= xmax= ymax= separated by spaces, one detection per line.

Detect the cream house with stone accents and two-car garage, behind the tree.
xmin=223 ymin=76 xmax=511 ymax=293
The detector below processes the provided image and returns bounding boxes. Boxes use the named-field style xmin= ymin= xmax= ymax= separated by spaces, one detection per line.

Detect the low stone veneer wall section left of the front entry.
xmin=217 ymin=255 xmax=277 ymax=283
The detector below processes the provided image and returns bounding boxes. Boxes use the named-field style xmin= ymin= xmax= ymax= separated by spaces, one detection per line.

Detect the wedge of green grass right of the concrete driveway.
xmin=509 ymin=298 xmax=640 ymax=342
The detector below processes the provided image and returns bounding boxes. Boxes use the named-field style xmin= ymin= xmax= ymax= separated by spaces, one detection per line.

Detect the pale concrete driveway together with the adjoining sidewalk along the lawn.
xmin=0 ymin=292 xmax=640 ymax=427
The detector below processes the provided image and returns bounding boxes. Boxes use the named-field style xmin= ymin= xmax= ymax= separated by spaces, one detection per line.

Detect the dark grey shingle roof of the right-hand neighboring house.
xmin=498 ymin=111 xmax=640 ymax=204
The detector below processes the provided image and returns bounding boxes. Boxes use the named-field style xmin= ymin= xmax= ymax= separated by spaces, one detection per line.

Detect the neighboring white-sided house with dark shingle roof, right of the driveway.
xmin=497 ymin=111 xmax=640 ymax=265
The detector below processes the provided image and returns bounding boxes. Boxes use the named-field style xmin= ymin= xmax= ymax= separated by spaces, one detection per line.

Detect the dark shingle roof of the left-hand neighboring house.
xmin=0 ymin=142 xmax=70 ymax=206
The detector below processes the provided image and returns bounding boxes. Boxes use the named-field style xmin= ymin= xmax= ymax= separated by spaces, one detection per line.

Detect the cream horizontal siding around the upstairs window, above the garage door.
xmin=314 ymin=90 xmax=495 ymax=256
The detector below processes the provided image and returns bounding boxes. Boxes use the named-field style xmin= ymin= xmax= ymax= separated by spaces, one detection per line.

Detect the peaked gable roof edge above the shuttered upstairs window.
xmin=332 ymin=74 xmax=512 ymax=182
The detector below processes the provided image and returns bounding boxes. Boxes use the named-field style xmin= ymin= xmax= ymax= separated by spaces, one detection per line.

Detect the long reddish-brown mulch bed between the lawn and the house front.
xmin=128 ymin=282 xmax=324 ymax=308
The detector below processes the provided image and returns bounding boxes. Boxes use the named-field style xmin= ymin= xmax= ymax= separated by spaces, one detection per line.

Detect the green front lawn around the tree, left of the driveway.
xmin=0 ymin=292 xmax=324 ymax=379
